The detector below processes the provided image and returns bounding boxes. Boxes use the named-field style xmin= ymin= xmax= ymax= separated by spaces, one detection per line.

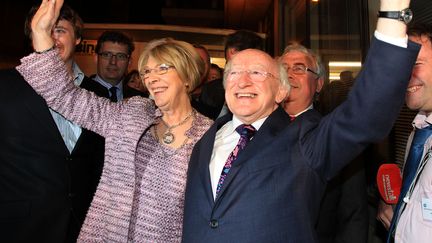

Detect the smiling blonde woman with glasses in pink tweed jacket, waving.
xmin=18 ymin=0 xmax=211 ymax=242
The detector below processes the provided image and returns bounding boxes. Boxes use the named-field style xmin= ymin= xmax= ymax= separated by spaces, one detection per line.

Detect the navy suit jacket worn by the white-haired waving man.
xmin=183 ymin=41 xmax=419 ymax=243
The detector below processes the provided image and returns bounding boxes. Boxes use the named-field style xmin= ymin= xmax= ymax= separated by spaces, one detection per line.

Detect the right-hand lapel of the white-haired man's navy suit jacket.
xmin=216 ymin=107 xmax=290 ymax=203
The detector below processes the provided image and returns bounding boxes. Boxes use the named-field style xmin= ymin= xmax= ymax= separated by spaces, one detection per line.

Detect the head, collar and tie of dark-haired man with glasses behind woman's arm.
xmin=93 ymin=31 xmax=135 ymax=102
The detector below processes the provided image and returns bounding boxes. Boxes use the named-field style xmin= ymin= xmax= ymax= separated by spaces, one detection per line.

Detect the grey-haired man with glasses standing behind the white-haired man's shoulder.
xmin=280 ymin=44 xmax=368 ymax=243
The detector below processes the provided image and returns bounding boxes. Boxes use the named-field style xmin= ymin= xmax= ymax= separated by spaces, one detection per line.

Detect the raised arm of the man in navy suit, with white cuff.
xmin=304 ymin=0 xmax=420 ymax=179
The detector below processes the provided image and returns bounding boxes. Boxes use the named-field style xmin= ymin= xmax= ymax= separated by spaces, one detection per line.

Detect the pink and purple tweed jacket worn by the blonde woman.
xmin=17 ymin=51 xmax=212 ymax=242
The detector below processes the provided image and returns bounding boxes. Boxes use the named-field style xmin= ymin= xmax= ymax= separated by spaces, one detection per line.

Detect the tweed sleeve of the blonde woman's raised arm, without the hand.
xmin=17 ymin=49 xmax=125 ymax=137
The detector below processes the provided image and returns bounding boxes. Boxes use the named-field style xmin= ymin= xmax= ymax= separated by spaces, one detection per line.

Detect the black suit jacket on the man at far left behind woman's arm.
xmin=0 ymin=69 xmax=104 ymax=243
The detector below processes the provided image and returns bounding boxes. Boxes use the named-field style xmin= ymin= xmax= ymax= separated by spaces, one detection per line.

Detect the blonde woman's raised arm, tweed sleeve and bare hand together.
xmin=17 ymin=0 xmax=138 ymax=137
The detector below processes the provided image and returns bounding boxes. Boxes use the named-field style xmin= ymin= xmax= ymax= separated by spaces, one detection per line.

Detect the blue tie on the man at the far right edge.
xmin=387 ymin=126 xmax=432 ymax=242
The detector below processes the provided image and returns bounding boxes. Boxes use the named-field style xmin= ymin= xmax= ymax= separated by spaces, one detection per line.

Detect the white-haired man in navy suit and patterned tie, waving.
xmin=183 ymin=0 xmax=419 ymax=243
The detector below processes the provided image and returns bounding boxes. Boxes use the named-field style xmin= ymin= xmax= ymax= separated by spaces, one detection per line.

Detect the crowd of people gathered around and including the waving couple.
xmin=0 ymin=0 xmax=432 ymax=243
